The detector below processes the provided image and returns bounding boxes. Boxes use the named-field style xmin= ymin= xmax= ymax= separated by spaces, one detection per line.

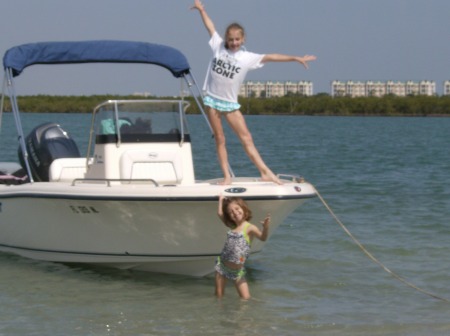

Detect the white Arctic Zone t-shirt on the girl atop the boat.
xmin=203 ymin=32 xmax=264 ymax=103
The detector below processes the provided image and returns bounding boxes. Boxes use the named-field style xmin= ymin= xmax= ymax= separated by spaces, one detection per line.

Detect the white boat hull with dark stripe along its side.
xmin=0 ymin=183 xmax=314 ymax=276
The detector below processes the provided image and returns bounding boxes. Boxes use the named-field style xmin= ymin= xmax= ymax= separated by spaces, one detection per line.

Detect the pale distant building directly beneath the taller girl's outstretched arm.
xmin=239 ymin=81 xmax=313 ymax=98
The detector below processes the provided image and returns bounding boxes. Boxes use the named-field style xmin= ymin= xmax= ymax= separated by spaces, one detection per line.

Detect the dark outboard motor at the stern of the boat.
xmin=19 ymin=123 xmax=80 ymax=182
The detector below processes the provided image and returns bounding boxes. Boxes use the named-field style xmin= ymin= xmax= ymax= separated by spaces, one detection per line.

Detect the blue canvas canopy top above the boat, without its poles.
xmin=3 ymin=40 xmax=190 ymax=77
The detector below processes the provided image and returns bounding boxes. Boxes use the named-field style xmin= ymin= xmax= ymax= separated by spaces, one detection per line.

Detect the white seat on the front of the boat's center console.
xmin=120 ymin=149 xmax=183 ymax=184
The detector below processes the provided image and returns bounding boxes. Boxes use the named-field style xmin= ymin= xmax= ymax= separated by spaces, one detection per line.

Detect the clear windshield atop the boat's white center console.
xmin=91 ymin=100 xmax=189 ymax=143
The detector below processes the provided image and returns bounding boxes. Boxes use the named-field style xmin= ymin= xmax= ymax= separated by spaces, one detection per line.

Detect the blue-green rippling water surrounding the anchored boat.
xmin=0 ymin=114 xmax=450 ymax=335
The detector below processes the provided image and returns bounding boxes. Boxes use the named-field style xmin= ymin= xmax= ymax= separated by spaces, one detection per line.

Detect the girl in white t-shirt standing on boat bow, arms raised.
xmin=191 ymin=0 xmax=316 ymax=185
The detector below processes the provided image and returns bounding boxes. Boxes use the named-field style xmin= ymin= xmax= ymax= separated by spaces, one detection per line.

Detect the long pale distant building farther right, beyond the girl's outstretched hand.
xmin=331 ymin=81 xmax=436 ymax=97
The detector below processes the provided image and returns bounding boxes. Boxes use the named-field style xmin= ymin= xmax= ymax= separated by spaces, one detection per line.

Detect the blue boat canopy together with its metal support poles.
xmin=0 ymin=40 xmax=229 ymax=183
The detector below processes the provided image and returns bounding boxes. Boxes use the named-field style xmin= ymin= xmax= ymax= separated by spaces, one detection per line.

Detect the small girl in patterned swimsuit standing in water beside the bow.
xmin=215 ymin=195 xmax=270 ymax=300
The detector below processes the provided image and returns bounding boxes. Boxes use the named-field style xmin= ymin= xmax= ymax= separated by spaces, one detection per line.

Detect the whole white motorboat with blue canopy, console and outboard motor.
xmin=0 ymin=41 xmax=316 ymax=276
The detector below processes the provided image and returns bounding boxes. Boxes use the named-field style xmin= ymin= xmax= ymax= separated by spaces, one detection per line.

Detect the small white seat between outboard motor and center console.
xmin=48 ymin=158 xmax=86 ymax=182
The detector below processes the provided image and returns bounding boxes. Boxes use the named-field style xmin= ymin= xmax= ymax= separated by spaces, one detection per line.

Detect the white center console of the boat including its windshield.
xmin=85 ymin=100 xmax=195 ymax=185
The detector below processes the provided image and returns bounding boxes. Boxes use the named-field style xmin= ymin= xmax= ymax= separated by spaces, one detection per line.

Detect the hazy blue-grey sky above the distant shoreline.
xmin=0 ymin=0 xmax=450 ymax=96
